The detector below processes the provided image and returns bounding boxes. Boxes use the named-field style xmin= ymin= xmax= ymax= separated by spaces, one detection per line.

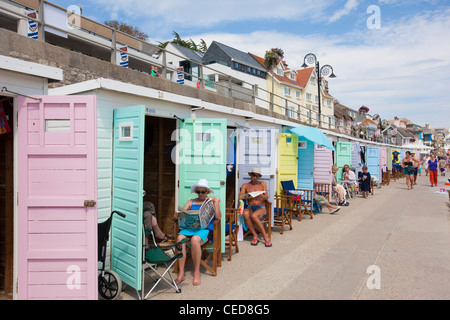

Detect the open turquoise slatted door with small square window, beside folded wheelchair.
xmin=111 ymin=105 xmax=145 ymax=290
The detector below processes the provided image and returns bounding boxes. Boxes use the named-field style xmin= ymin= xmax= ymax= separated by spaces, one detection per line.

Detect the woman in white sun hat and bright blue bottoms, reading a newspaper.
xmin=174 ymin=179 xmax=221 ymax=286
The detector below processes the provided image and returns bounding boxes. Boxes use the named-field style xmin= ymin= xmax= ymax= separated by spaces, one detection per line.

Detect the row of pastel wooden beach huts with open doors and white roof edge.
xmin=0 ymin=61 xmax=422 ymax=299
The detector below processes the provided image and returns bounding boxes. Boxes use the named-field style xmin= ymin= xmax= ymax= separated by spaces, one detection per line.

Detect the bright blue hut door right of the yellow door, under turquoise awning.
xmin=297 ymin=139 xmax=314 ymax=190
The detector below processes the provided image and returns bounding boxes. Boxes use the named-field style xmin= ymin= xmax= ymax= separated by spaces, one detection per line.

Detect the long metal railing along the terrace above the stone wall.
xmin=0 ymin=0 xmax=404 ymax=145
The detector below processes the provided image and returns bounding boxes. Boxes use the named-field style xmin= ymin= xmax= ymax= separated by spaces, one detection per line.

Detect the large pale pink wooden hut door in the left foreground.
xmin=17 ymin=96 xmax=98 ymax=300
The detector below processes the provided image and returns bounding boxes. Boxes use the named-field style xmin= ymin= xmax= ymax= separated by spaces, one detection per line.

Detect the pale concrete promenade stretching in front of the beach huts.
xmin=120 ymin=175 xmax=450 ymax=300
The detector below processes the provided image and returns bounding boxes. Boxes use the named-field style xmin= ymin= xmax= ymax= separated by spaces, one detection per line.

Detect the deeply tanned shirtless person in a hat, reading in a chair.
xmin=239 ymin=168 xmax=272 ymax=247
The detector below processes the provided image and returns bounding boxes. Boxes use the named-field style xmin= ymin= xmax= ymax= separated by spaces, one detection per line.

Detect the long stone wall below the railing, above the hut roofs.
xmin=0 ymin=29 xmax=293 ymax=121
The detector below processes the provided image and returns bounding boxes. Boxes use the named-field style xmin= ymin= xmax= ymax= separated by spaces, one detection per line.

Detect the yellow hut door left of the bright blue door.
xmin=277 ymin=133 xmax=298 ymax=194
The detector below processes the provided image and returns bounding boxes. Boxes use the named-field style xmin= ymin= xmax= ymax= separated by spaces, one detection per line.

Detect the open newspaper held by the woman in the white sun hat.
xmin=178 ymin=198 xmax=214 ymax=229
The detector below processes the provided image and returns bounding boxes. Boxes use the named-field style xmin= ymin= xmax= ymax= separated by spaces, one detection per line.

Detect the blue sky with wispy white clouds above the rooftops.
xmin=51 ymin=0 xmax=450 ymax=128
